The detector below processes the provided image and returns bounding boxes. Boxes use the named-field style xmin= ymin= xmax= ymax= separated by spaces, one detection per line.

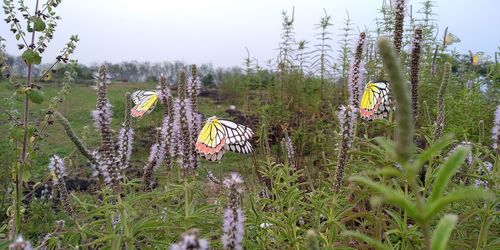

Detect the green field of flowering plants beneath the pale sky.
xmin=0 ymin=1 xmax=500 ymax=250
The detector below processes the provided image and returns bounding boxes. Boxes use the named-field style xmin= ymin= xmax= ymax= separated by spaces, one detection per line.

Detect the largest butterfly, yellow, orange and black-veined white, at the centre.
xmin=195 ymin=116 xmax=253 ymax=161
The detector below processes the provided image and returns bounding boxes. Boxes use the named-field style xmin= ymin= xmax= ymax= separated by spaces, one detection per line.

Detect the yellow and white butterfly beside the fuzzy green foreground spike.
xmin=359 ymin=81 xmax=390 ymax=120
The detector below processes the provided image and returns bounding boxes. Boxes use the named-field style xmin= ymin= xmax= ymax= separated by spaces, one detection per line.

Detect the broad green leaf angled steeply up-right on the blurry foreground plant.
xmin=429 ymin=146 xmax=470 ymax=202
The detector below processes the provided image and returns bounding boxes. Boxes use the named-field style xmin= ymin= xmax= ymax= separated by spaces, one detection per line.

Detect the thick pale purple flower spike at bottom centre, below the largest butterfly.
xmin=222 ymin=173 xmax=245 ymax=249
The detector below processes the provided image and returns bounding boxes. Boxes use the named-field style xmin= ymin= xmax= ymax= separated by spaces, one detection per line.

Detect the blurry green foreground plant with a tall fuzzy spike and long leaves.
xmin=346 ymin=37 xmax=490 ymax=249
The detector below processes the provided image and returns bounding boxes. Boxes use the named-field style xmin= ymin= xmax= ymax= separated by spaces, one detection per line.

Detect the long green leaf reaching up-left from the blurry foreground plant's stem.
xmin=349 ymin=176 xmax=422 ymax=221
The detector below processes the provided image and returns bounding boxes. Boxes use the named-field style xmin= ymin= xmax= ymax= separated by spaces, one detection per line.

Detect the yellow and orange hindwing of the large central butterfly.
xmin=195 ymin=118 xmax=226 ymax=161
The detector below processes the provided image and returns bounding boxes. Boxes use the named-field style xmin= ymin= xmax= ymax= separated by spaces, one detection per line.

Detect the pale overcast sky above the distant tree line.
xmin=0 ymin=0 xmax=500 ymax=67
